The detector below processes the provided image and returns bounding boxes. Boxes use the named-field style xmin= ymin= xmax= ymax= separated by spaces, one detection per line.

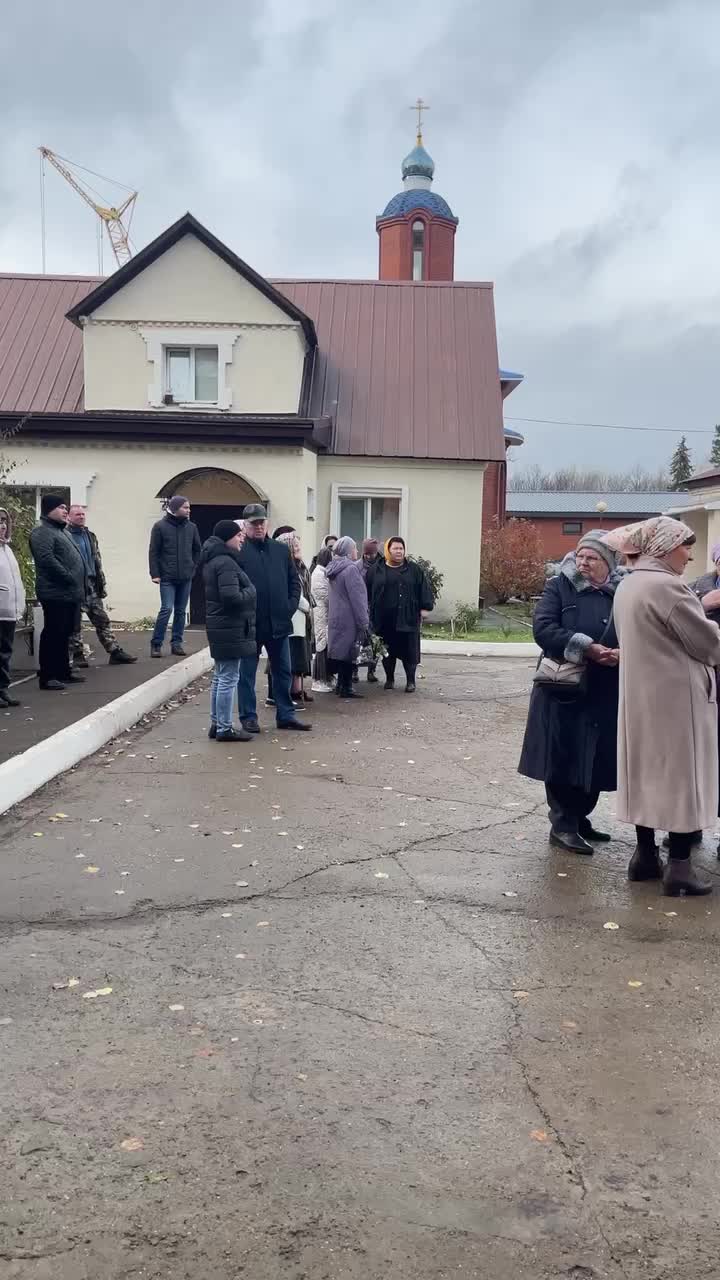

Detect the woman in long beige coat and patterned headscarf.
xmin=607 ymin=516 xmax=720 ymax=896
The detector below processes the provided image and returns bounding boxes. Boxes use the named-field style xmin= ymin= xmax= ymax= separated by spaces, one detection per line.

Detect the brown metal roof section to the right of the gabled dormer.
xmin=273 ymin=280 xmax=505 ymax=460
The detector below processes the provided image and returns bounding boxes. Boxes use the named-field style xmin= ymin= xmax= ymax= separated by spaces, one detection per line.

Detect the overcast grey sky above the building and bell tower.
xmin=0 ymin=0 xmax=720 ymax=466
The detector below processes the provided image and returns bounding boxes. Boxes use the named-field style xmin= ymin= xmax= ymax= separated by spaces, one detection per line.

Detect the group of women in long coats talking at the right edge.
xmin=519 ymin=516 xmax=720 ymax=895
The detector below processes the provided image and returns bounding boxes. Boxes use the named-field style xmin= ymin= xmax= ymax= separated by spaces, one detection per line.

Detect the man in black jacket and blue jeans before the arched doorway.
xmin=149 ymin=494 xmax=202 ymax=658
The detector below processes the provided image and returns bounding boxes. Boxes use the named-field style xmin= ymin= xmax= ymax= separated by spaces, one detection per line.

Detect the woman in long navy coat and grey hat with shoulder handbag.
xmin=518 ymin=530 xmax=623 ymax=854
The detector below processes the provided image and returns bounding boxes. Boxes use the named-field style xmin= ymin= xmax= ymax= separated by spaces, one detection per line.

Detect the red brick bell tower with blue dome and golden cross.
xmin=375 ymin=99 xmax=457 ymax=280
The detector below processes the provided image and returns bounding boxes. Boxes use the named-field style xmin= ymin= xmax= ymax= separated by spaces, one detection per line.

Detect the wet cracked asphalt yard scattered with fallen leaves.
xmin=0 ymin=657 xmax=720 ymax=1280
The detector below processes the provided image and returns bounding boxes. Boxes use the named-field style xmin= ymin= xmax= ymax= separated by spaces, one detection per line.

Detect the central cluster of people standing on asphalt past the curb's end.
xmin=196 ymin=499 xmax=433 ymax=741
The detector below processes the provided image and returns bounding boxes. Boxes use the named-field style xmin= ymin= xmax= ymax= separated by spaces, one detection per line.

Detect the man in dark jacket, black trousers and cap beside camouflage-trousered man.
xmin=29 ymin=493 xmax=87 ymax=690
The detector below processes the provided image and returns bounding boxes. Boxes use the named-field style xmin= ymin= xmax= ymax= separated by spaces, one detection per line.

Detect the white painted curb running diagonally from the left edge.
xmin=0 ymin=649 xmax=213 ymax=813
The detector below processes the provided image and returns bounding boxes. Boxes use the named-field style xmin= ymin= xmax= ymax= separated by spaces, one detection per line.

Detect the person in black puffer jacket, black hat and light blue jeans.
xmin=200 ymin=520 xmax=256 ymax=742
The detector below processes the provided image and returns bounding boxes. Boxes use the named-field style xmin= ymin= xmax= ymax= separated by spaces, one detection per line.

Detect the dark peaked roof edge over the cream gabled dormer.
xmin=68 ymin=214 xmax=318 ymax=348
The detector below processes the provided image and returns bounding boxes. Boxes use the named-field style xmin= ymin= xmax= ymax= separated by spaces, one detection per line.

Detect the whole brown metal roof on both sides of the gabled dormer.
xmin=0 ymin=274 xmax=505 ymax=461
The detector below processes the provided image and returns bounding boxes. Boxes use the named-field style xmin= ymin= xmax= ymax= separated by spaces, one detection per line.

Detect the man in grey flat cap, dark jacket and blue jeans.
xmin=237 ymin=503 xmax=311 ymax=733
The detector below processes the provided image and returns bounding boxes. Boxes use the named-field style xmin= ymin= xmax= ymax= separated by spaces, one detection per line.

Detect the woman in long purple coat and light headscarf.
xmin=325 ymin=538 xmax=369 ymax=698
